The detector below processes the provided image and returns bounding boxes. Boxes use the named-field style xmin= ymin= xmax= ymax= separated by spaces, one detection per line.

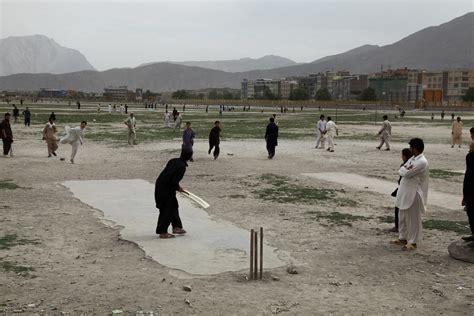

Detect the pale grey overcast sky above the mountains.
xmin=0 ymin=0 xmax=474 ymax=70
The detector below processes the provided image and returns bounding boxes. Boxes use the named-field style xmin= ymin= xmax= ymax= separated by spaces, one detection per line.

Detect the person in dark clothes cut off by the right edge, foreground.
xmin=461 ymin=127 xmax=474 ymax=241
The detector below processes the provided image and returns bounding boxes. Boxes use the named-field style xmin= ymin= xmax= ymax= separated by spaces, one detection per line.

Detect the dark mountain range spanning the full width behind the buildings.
xmin=0 ymin=12 xmax=474 ymax=92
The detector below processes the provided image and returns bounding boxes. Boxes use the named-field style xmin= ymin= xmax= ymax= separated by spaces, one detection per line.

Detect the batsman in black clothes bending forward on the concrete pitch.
xmin=155 ymin=150 xmax=193 ymax=238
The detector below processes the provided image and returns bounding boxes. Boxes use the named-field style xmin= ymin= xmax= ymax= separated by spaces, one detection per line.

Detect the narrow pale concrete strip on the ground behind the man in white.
xmin=302 ymin=172 xmax=462 ymax=210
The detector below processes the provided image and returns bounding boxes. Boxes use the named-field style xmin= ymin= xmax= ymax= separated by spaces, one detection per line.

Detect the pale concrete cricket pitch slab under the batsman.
xmin=63 ymin=179 xmax=286 ymax=278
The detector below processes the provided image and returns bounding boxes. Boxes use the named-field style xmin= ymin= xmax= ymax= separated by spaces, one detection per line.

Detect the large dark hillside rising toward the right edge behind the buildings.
xmin=243 ymin=12 xmax=474 ymax=78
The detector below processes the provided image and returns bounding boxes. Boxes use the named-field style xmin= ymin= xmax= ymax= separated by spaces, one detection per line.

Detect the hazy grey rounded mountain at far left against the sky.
xmin=0 ymin=35 xmax=94 ymax=76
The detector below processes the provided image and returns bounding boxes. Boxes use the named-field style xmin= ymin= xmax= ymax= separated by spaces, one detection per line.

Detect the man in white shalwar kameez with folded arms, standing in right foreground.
xmin=392 ymin=138 xmax=429 ymax=250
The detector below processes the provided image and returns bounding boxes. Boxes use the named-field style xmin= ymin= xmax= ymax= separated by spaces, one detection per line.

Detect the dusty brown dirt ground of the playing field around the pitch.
xmin=0 ymin=115 xmax=474 ymax=315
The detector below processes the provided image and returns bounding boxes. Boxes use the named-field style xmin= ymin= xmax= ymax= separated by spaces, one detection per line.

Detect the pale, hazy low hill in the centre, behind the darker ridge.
xmin=142 ymin=55 xmax=297 ymax=72
